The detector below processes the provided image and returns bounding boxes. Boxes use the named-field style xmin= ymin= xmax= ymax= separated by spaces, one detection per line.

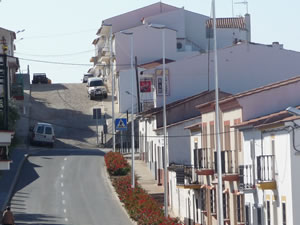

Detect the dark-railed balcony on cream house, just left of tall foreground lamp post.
xmin=194 ymin=148 xmax=214 ymax=176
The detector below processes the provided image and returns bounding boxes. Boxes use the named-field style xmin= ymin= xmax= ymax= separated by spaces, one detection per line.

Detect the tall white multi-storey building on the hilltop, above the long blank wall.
xmin=92 ymin=2 xmax=251 ymax=112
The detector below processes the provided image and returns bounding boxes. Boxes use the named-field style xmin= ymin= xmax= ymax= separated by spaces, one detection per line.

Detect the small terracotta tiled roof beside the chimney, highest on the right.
xmin=206 ymin=17 xmax=246 ymax=29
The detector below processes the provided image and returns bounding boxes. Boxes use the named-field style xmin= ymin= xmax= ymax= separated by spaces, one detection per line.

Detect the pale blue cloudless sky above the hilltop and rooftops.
xmin=0 ymin=0 xmax=300 ymax=83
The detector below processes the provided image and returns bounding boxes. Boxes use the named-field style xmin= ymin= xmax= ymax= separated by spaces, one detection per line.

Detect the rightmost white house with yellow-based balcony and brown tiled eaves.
xmin=239 ymin=107 xmax=300 ymax=225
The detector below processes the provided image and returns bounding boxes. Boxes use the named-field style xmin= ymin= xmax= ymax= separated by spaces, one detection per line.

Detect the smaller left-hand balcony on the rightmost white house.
xmin=239 ymin=165 xmax=255 ymax=191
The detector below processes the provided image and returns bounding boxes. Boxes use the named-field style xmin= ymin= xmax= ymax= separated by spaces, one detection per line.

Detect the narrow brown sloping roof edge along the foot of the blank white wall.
xmin=140 ymin=90 xmax=231 ymax=117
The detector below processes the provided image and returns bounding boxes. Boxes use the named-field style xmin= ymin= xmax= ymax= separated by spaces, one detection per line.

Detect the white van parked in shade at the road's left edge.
xmin=29 ymin=122 xmax=55 ymax=147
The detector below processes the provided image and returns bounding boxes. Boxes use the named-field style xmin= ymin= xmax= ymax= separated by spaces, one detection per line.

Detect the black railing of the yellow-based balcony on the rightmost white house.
xmin=257 ymin=155 xmax=275 ymax=182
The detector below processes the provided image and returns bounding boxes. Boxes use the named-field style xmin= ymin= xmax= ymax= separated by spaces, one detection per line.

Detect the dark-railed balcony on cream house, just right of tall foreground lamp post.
xmin=214 ymin=150 xmax=239 ymax=182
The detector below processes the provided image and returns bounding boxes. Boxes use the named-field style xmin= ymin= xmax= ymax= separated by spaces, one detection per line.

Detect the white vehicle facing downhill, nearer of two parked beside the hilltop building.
xmin=87 ymin=77 xmax=107 ymax=100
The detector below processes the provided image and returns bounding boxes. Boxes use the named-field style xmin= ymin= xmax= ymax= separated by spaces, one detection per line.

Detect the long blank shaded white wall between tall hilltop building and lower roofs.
xmin=142 ymin=43 xmax=300 ymax=106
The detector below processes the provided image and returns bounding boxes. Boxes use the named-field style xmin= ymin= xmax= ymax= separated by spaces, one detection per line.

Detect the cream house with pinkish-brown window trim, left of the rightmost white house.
xmin=169 ymin=76 xmax=300 ymax=225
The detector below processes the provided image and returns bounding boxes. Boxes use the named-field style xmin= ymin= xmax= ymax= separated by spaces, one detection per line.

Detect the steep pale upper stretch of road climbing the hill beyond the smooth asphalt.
xmin=30 ymin=84 xmax=111 ymax=148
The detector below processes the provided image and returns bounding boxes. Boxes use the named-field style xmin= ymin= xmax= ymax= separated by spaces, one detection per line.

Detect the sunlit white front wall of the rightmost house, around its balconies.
xmin=243 ymin=125 xmax=300 ymax=225
